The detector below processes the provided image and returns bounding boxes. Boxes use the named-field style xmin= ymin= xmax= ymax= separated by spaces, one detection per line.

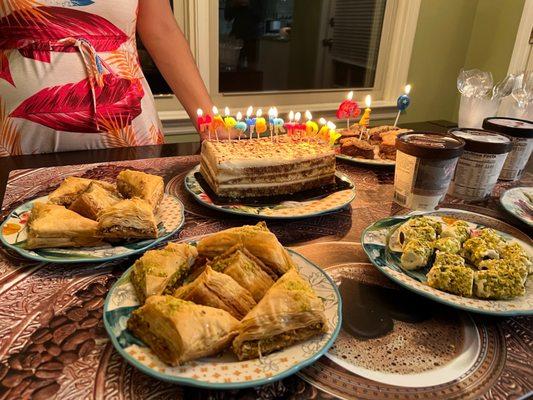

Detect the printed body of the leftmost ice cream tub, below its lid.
xmin=394 ymin=151 xmax=457 ymax=210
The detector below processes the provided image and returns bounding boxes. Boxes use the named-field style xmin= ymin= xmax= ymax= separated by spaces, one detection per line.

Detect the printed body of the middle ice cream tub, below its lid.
xmin=450 ymin=151 xmax=507 ymax=200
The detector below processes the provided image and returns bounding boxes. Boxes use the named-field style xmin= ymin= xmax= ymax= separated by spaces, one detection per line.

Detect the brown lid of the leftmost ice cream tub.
xmin=396 ymin=132 xmax=465 ymax=160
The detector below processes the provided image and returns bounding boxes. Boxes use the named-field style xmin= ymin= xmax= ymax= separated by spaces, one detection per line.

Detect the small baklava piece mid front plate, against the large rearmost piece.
xmin=209 ymin=245 xmax=277 ymax=301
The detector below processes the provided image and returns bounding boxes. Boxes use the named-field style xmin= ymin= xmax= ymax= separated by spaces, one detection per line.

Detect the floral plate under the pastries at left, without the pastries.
xmin=0 ymin=194 xmax=185 ymax=264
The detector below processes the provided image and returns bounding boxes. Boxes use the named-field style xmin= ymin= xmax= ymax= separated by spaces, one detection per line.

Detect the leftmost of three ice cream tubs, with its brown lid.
xmin=394 ymin=132 xmax=465 ymax=211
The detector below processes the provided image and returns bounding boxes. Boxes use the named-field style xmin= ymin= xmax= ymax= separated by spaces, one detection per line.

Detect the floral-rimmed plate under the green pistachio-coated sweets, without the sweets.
xmin=361 ymin=209 xmax=533 ymax=316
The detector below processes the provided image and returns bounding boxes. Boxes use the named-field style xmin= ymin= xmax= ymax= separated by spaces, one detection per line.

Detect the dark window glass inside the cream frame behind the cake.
xmin=219 ymin=0 xmax=386 ymax=92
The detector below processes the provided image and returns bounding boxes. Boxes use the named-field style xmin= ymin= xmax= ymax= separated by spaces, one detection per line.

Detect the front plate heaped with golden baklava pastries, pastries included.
xmin=104 ymin=222 xmax=341 ymax=389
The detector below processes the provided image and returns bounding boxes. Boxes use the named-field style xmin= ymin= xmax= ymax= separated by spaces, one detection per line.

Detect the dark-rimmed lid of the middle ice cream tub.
xmin=448 ymin=128 xmax=513 ymax=154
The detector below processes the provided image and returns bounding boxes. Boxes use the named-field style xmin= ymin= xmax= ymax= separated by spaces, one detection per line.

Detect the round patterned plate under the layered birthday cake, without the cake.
xmin=185 ymin=166 xmax=355 ymax=220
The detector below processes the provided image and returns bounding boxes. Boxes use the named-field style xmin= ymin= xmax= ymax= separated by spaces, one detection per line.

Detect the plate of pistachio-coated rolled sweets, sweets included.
xmin=361 ymin=209 xmax=533 ymax=315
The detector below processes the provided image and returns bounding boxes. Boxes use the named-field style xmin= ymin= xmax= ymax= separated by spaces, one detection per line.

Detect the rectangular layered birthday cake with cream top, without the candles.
xmin=200 ymin=135 xmax=335 ymax=198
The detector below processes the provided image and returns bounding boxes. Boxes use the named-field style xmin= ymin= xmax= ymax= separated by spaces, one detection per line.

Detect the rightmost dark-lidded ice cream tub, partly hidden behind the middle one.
xmin=483 ymin=117 xmax=533 ymax=181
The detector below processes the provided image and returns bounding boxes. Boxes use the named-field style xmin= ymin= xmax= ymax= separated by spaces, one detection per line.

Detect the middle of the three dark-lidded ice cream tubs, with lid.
xmin=448 ymin=128 xmax=512 ymax=201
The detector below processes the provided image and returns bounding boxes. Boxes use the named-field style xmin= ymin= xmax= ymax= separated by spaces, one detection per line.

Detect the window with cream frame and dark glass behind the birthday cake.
xmin=150 ymin=0 xmax=421 ymax=125
